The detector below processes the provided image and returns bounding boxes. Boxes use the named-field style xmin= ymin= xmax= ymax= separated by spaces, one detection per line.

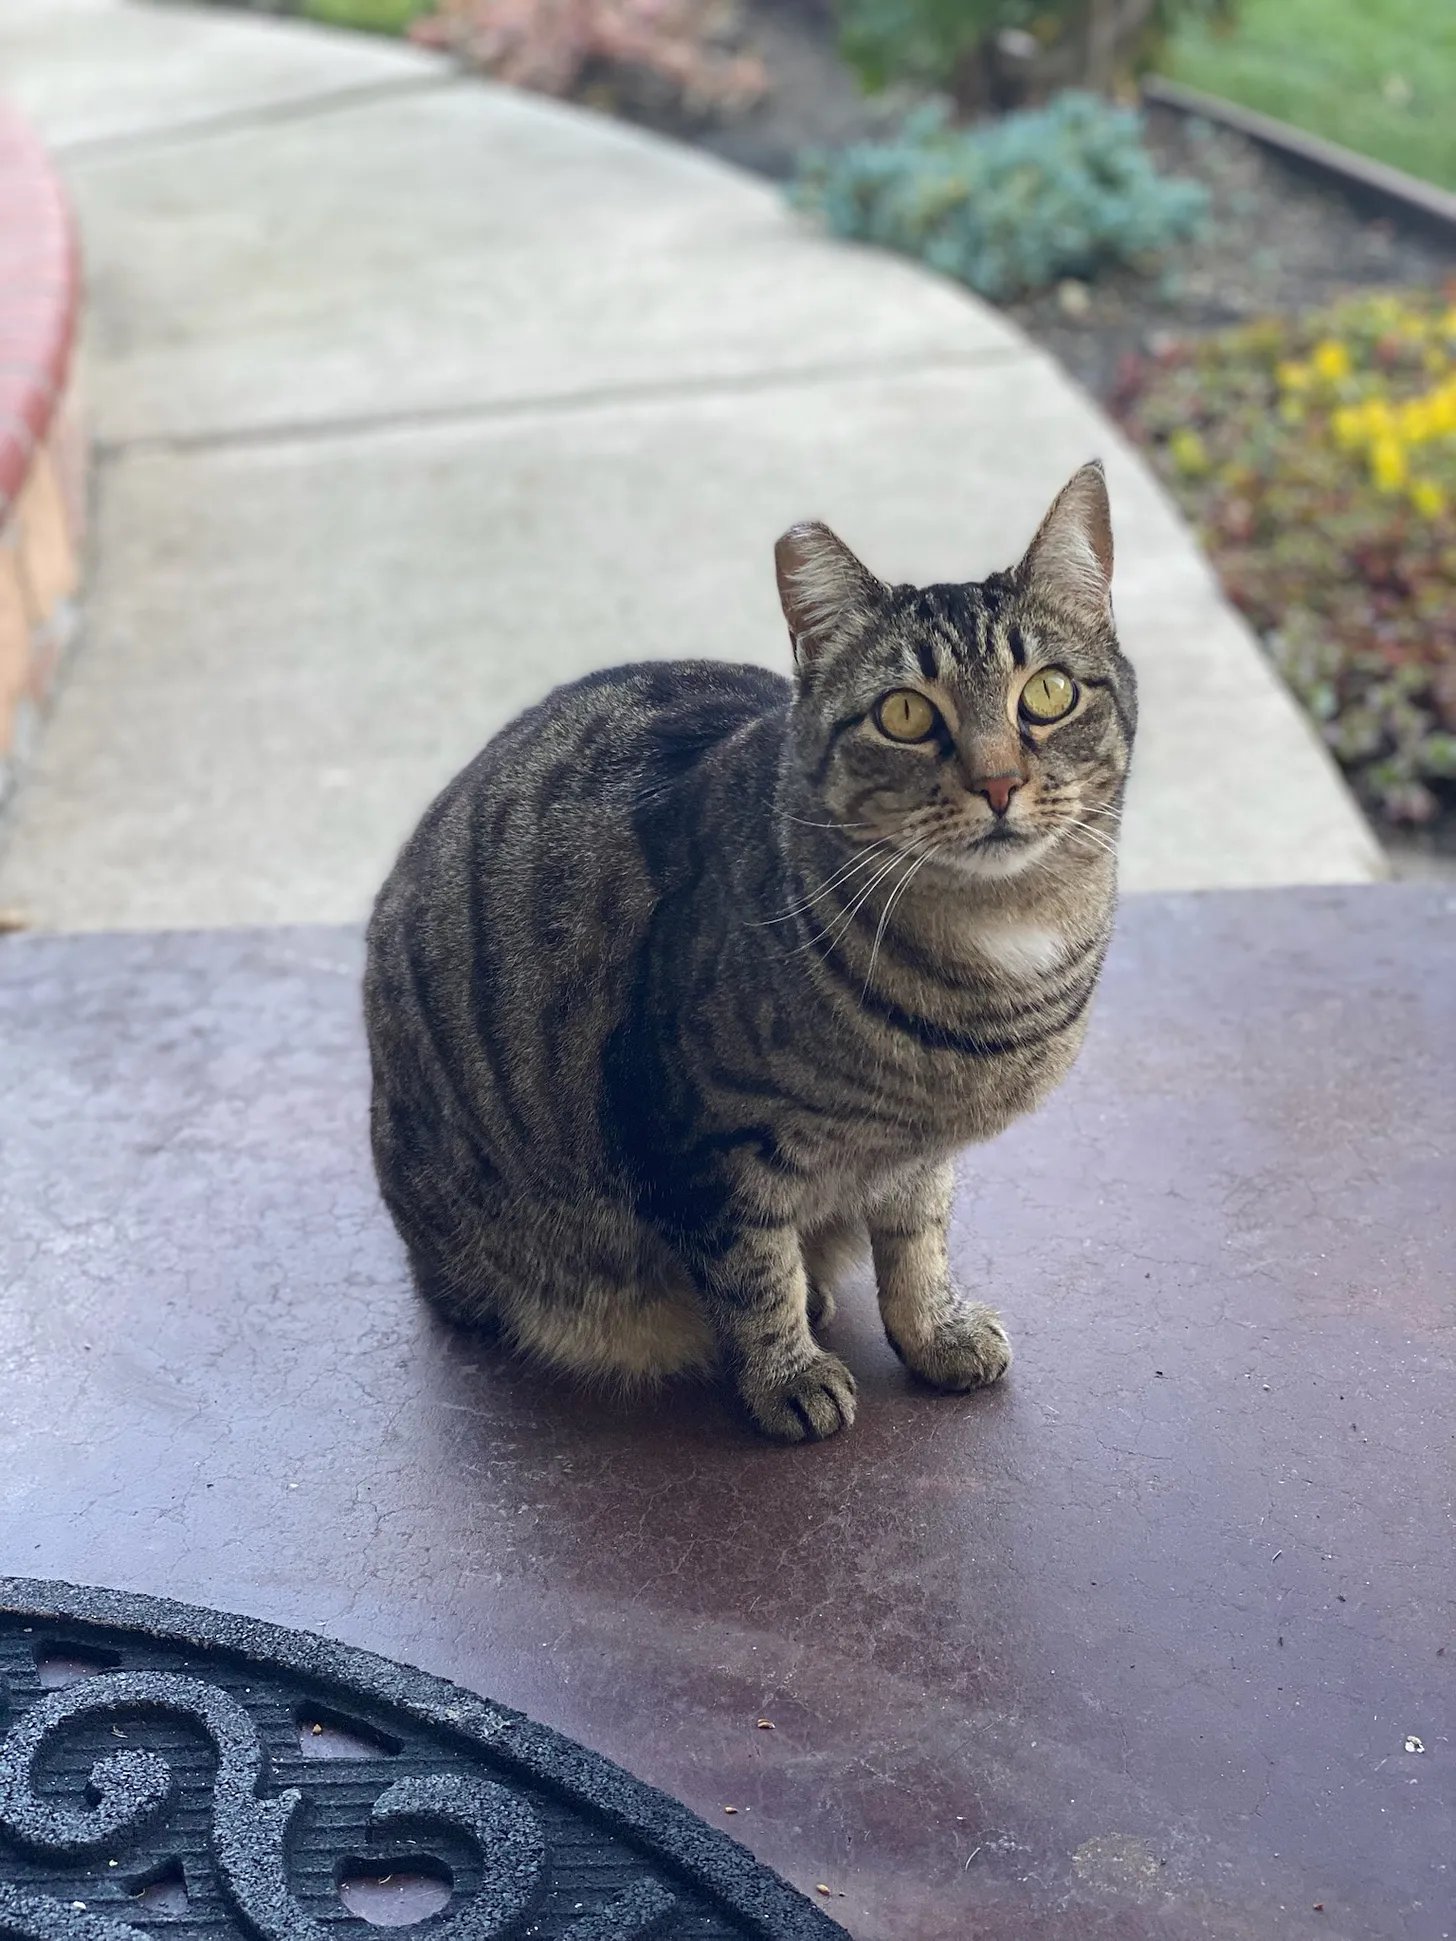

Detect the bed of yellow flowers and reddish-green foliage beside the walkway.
xmin=1120 ymin=285 xmax=1456 ymax=831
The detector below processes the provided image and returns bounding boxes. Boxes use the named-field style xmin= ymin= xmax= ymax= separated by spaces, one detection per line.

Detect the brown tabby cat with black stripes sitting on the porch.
xmin=365 ymin=464 xmax=1136 ymax=1440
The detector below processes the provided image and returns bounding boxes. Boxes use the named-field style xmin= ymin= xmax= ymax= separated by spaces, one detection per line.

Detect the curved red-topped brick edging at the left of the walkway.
xmin=0 ymin=101 xmax=85 ymax=819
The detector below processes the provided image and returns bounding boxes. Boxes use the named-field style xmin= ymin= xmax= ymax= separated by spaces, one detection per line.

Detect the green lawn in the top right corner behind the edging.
xmin=1159 ymin=0 xmax=1456 ymax=188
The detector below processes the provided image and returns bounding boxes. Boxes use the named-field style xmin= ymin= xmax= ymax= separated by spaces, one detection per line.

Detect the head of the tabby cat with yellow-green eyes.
xmin=777 ymin=464 xmax=1138 ymax=877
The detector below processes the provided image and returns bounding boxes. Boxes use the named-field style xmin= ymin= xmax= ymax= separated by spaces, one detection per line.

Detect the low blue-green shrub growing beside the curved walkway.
xmin=792 ymin=89 xmax=1208 ymax=303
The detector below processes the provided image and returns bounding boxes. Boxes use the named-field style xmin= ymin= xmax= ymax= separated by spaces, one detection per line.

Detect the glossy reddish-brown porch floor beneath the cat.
xmin=0 ymin=887 xmax=1456 ymax=1941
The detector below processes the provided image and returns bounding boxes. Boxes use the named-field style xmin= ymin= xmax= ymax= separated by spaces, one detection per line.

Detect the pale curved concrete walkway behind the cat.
xmin=0 ymin=0 xmax=1382 ymax=928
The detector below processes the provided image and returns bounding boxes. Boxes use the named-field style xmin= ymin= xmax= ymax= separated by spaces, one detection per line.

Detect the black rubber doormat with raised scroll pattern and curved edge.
xmin=0 ymin=1578 xmax=844 ymax=1941
